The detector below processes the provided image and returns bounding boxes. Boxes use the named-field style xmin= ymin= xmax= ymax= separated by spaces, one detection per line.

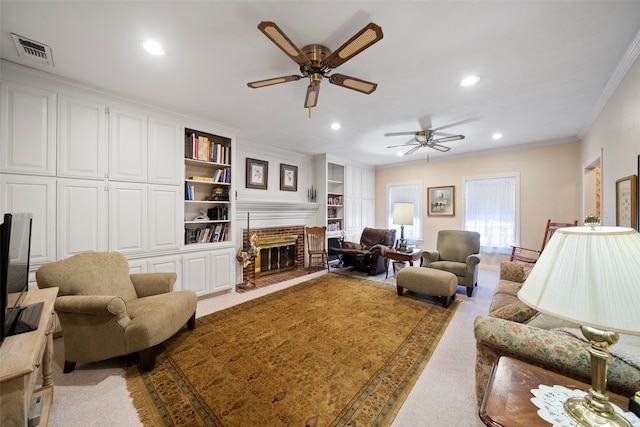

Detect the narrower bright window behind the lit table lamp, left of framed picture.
xmin=387 ymin=183 xmax=422 ymax=245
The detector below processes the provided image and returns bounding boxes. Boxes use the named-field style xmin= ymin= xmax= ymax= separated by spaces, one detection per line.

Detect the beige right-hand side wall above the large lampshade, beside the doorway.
xmin=580 ymin=55 xmax=640 ymax=225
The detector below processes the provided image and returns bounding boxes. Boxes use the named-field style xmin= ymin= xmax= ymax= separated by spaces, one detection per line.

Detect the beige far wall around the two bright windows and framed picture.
xmin=376 ymin=142 xmax=582 ymax=264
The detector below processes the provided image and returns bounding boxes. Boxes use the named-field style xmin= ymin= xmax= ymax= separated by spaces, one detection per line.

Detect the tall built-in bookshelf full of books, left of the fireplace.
xmin=184 ymin=129 xmax=231 ymax=245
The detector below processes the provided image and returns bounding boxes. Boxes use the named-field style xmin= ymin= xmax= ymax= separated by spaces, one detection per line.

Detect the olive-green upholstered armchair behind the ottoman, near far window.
xmin=422 ymin=230 xmax=481 ymax=296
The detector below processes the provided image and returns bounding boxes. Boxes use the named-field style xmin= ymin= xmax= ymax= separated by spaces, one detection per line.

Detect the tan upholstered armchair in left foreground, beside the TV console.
xmin=36 ymin=252 xmax=197 ymax=373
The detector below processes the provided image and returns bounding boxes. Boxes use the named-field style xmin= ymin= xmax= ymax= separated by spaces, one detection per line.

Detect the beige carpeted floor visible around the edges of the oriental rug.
xmin=42 ymin=265 xmax=498 ymax=427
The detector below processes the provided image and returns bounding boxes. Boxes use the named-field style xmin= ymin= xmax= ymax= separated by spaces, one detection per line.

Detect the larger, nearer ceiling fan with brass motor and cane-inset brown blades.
xmin=247 ymin=21 xmax=382 ymax=116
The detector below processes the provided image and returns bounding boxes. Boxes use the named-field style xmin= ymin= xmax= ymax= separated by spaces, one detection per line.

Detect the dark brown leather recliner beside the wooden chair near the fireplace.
xmin=329 ymin=227 xmax=396 ymax=275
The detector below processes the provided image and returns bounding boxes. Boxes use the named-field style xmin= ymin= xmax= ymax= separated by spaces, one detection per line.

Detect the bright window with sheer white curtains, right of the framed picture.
xmin=463 ymin=174 xmax=520 ymax=254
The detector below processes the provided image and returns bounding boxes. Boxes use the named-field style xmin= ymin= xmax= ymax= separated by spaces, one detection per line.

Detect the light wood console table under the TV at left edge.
xmin=0 ymin=288 xmax=58 ymax=426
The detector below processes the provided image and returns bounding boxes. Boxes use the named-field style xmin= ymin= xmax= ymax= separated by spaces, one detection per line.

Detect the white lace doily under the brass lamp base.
xmin=531 ymin=384 xmax=640 ymax=427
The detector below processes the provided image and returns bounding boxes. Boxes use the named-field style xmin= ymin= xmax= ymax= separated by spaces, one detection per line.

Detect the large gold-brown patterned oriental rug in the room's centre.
xmin=127 ymin=273 xmax=459 ymax=427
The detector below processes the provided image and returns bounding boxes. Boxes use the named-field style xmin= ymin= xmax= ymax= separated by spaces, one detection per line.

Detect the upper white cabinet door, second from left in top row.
xmin=58 ymin=95 xmax=107 ymax=179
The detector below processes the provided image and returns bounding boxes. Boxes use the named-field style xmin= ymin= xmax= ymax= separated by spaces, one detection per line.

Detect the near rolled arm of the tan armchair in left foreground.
xmin=55 ymin=295 xmax=131 ymax=327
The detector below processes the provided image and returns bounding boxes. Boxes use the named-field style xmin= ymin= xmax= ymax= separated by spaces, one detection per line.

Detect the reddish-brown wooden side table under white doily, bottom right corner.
xmin=479 ymin=356 xmax=629 ymax=427
